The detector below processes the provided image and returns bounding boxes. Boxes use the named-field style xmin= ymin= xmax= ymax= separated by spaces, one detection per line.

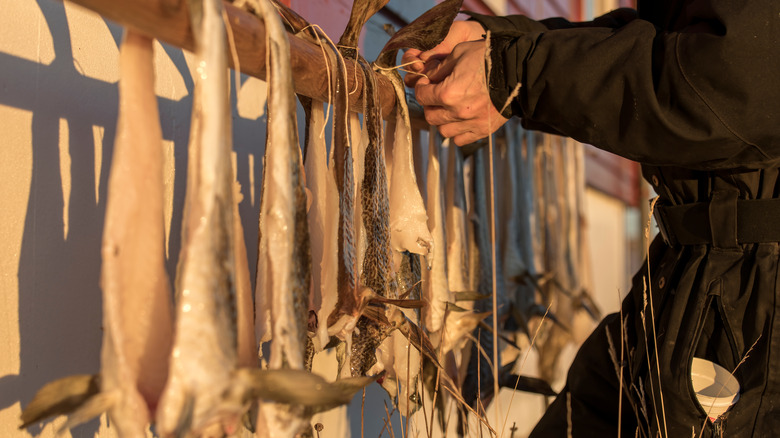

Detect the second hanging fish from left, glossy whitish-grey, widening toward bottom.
xmin=157 ymin=0 xmax=245 ymax=437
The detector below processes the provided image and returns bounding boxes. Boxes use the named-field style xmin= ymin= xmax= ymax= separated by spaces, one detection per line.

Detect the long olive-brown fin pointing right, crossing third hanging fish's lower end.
xmin=236 ymin=368 xmax=379 ymax=413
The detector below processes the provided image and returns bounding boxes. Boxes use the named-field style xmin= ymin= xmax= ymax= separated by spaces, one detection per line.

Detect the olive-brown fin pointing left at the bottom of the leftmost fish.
xmin=19 ymin=374 xmax=100 ymax=429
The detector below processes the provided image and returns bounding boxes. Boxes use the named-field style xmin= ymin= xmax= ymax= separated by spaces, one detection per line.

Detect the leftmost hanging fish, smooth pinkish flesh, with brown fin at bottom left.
xmin=21 ymin=29 xmax=172 ymax=437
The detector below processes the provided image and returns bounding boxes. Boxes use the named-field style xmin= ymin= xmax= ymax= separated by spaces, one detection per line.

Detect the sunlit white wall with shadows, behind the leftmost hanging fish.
xmin=0 ymin=0 xmax=272 ymax=437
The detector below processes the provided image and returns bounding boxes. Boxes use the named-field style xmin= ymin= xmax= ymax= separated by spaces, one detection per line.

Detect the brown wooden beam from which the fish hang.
xmin=64 ymin=0 xmax=395 ymax=117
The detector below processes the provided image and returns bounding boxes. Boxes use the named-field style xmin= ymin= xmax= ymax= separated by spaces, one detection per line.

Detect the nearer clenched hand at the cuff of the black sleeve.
xmin=414 ymin=40 xmax=508 ymax=146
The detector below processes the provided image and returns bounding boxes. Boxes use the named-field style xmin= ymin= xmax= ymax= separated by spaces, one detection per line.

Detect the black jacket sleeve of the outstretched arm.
xmin=470 ymin=0 xmax=780 ymax=169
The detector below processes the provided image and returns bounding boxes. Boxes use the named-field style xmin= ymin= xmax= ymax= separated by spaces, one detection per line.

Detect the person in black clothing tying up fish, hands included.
xmin=403 ymin=0 xmax=780 ymax=437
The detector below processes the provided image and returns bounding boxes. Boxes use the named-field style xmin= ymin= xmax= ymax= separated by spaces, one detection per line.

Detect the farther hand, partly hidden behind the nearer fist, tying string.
xmin=401 ymin=21 xmax=485 ymax=88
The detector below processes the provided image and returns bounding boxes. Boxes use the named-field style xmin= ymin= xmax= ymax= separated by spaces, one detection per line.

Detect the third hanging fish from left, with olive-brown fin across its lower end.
xmin=238 ymin=0 xmax=374 ymax=437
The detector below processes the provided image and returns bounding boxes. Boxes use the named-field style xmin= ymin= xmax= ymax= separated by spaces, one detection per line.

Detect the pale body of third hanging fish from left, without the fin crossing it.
xmin=251 ymin=0 xmax=311 ymax=437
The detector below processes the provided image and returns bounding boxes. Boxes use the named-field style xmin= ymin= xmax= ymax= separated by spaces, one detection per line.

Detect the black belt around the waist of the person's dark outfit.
xmin=653 ymin=199 xmax=780 ymax=246
